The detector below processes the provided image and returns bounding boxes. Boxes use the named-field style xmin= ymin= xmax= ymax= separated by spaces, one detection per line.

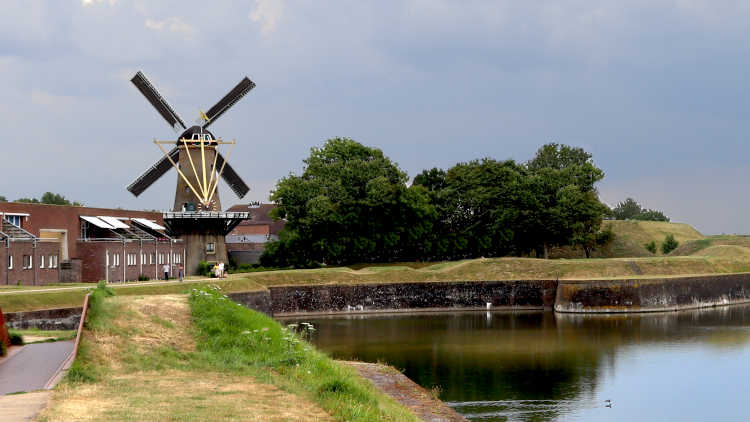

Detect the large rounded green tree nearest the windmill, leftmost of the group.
xmin=261 ymin=138 xmax=435 ymax=267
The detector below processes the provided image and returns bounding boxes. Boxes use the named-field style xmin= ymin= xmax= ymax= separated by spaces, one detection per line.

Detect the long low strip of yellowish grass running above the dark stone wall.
xmin=7 ymin=251 xmax=750 ymax=312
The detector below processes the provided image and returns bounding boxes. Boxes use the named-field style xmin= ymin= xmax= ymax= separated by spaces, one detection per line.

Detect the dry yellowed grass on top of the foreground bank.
xmin=42 ymin=295 xmax=332 ymax=422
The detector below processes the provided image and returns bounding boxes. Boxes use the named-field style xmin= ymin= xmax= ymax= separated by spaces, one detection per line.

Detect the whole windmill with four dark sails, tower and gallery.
xmin=127 ymin=71 xmax=255 ymax=275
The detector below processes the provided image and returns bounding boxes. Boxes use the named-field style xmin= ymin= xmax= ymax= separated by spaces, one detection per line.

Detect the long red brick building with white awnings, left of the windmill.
xmin=0 ymin=202 xmax=185 ymax=284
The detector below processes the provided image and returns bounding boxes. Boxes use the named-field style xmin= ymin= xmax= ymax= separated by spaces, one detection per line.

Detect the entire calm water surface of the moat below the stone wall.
xmin=282 ymin=305 xmax=750 ymax=422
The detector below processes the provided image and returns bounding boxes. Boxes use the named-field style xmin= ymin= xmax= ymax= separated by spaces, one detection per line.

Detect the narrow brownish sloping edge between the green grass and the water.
xmin=342 ymin=362 xmax=467 ymax=422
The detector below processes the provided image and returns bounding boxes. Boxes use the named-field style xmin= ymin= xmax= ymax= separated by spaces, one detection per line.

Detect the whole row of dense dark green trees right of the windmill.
xmin=261 ymin=138 xmax=613 ymax=267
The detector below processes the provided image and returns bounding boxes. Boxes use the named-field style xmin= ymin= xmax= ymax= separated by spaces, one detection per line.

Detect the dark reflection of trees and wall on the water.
xmin=290 ymin=305 xmax=750 ymax=421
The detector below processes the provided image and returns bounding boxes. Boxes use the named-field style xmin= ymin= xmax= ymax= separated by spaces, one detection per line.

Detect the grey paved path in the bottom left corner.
xmin=0 ymin=340 xmax=75 ymax=395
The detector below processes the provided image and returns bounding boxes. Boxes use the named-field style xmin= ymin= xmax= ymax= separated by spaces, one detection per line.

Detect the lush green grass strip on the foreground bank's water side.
xmin=190 ymin=289 xmax=418 ymax=422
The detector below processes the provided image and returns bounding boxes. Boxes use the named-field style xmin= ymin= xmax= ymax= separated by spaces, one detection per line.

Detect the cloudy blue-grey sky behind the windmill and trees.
xmin=0 ymin=0 xmax=750 ymax=234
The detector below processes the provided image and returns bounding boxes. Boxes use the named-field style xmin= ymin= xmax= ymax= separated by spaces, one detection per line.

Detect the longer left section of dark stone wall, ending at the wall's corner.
xmin=269 ymin=280 xmax=557 ymax=315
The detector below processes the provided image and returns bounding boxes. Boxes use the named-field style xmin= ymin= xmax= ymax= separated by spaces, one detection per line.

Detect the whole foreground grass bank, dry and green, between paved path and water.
xmin=40 ymin=289 xmax=416 ymax=421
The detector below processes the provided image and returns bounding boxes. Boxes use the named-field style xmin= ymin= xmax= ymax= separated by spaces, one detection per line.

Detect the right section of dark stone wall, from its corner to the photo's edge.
xmin=555 ymin=274 xmax=750 ymax=312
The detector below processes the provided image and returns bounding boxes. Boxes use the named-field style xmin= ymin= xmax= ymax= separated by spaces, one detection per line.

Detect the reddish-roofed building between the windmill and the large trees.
xmin=226 ymin=204 xmax=285 ymax=264
